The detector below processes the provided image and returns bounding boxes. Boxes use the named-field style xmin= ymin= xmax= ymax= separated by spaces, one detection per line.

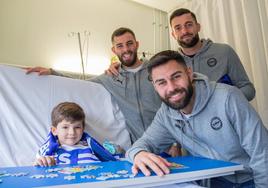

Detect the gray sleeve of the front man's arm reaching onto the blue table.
xmin=126 ymin=109 xmax=175 ymax=162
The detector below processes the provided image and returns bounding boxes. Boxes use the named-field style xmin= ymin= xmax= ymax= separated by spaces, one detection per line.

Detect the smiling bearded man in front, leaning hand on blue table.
xmin=126 ymin=51 xmax=268 ymax=188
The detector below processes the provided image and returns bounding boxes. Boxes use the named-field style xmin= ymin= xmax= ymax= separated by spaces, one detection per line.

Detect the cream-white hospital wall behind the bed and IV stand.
xmin=0 ymin=0 xmax=169 ymax=74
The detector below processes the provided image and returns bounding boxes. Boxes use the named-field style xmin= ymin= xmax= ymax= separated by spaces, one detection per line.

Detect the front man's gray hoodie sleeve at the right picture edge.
xmin=226 ymin=88 xmax=268 ymax=188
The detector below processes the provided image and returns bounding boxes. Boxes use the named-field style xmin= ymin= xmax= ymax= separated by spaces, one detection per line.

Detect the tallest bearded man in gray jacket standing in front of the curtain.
xmin=169 ymin=8 xmax=255 ymax=101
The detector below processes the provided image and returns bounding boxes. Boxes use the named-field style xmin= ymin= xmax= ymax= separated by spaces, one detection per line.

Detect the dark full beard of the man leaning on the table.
xmin=161 ymin=79 xmax=193 ymax=110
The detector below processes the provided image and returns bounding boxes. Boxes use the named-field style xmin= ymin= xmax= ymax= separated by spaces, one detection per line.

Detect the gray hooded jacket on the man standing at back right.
xmin=180 ymin=39 xmax=255 ymax=101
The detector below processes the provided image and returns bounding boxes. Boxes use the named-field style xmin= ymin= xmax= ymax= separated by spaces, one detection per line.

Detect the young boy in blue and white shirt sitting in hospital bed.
xmin=34 ymin=102 xmax=116 ymax=166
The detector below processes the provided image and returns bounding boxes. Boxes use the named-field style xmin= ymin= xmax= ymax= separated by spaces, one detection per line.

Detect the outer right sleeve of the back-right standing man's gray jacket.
xmin=228 ymin=46 xmax=255 ymax=101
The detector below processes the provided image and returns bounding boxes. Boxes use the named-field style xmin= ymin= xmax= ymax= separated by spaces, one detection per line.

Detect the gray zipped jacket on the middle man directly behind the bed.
xmin=90 ymin=62 xmax=161 ymax=143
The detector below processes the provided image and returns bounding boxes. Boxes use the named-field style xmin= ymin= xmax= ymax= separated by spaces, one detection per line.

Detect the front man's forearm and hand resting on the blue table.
xmin=126 ymin=108 xmax=175 ymax=176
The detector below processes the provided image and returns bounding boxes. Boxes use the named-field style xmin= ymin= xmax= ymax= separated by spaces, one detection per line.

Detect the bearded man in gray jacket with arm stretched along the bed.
xmin=26 ymin=27 xmax=180 ymax=156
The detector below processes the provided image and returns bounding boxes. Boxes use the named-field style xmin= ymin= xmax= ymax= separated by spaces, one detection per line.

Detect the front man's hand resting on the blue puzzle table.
xmin=132 ymin=151 xmax=171 ymax=176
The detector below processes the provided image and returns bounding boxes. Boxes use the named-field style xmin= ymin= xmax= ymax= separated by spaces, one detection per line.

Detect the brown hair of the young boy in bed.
xmin=51 ymin=102 xmax=85 ymax=127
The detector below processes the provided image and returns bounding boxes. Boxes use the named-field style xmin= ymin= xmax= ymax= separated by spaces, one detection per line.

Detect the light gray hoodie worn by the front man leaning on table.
xmin=127 ymin=73 xmax=268 ymax=188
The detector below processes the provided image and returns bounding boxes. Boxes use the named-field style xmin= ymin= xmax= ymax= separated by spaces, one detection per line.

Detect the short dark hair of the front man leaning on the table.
xmin=147 ymin=50 xmax=187 ymax=81
